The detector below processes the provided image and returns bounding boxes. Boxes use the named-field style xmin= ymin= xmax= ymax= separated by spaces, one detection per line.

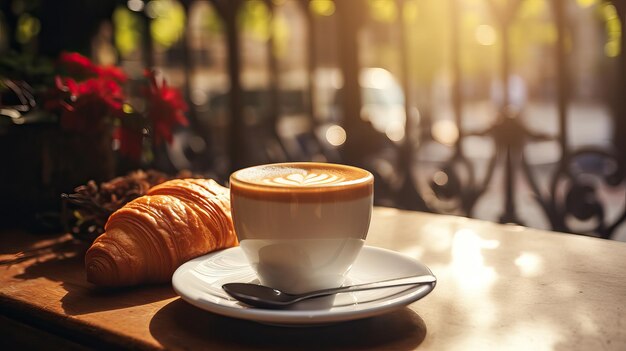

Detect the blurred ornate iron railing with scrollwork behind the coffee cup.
xmin=155 ymin=0 xmax=626 ymax=238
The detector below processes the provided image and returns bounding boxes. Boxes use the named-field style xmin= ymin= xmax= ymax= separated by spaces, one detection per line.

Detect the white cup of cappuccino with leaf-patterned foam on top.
xmin=230 ymin=162 xmax=374 ymax=293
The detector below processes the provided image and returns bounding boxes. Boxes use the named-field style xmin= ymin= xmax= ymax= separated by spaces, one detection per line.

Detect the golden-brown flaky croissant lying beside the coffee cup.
xmin=85 ymin=179 xmax=238 ymax=286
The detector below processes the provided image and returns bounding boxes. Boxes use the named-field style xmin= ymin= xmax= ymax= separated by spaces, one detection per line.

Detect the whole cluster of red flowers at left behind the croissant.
xmin=44 ymin=53 xmax=188 ymax=160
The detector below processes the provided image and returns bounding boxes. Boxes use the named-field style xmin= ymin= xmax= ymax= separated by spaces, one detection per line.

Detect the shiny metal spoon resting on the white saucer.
xmin=222 ymin=274 xmax=437 ymax=308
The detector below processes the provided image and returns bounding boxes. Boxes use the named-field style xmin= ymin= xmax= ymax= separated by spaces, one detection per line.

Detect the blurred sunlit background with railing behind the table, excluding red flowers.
xmin=0 ymin=0 xmax=626 ymax=240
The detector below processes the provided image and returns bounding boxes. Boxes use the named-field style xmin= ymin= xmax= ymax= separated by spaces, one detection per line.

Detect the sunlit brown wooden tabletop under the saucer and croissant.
xmin=0 ymin=208 xmax=626 ymax=350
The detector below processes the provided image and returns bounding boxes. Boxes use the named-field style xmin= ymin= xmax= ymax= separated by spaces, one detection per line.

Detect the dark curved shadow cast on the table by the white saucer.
xmin=150 ymin=299 xmax=426 ymax=350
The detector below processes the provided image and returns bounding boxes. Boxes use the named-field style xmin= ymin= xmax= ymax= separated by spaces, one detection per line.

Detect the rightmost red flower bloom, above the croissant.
xmin=145 ymin=71 xmax=189 ymax=145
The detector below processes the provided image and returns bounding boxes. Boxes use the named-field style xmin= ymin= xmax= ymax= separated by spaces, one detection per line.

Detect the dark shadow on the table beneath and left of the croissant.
xmin=15 ymin=252 xmax=176 ymax=315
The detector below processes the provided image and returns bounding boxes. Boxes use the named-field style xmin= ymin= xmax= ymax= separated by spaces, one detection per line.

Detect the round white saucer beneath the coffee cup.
xmin=172 ymin=246 xmax=435 ymax=325
